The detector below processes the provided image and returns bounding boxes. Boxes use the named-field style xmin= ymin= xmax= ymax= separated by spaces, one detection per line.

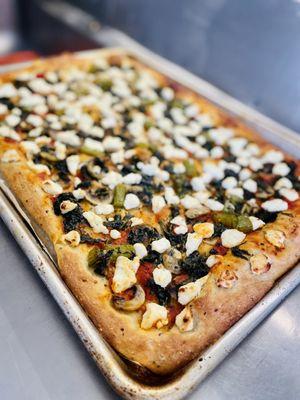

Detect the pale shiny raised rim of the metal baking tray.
xmin=0 ymin=46 xmax=300 ymax=400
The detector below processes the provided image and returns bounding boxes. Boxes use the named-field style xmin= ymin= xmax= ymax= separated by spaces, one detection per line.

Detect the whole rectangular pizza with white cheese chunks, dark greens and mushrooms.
xmin=0 ymin=50 xmax=300 ymax=375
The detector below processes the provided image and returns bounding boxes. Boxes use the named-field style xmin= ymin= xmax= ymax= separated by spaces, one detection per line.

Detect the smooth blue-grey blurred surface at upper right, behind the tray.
xmin=68 ymin=0 xmax=300 ymax=131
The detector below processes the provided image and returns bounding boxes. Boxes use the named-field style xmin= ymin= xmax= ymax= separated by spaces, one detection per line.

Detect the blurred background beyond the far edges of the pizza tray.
xmin=0 ymin=0 xmax=300 ymax=131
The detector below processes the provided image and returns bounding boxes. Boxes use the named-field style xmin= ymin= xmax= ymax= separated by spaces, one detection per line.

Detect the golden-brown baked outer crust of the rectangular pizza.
xmin=0 ymin=49 xmax=300 ymax=374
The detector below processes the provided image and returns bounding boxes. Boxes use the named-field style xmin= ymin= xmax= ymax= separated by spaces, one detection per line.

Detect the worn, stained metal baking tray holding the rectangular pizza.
xmin=0 ymin=44 xmax=300 ymax=400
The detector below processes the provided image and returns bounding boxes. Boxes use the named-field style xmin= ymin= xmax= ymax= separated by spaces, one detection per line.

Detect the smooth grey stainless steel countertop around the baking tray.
xmin=0 ymin=0 xmax=300 ymax=400
